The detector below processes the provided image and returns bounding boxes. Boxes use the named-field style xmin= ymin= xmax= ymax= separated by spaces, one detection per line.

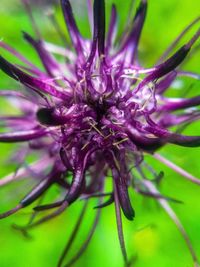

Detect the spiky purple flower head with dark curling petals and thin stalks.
xmin=0 ymin=0 xmax=200 ymax=266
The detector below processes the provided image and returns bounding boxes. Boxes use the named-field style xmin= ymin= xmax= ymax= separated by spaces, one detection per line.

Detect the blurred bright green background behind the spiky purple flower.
xmin=0 ymin=0 xmax=200 ymax=267
